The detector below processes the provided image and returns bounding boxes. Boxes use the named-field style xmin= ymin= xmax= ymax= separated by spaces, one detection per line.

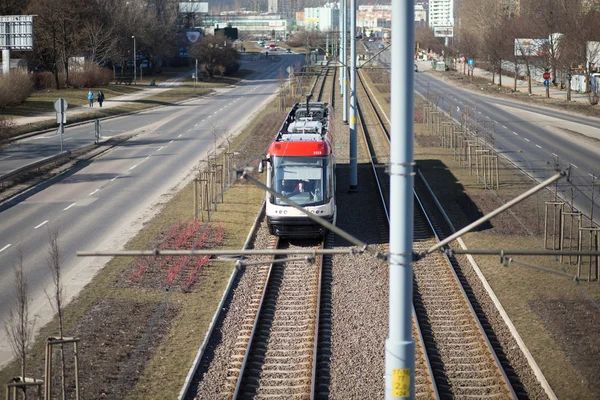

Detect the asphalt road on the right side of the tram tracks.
xmin=365 ymin=42 xmax=600 ymax=228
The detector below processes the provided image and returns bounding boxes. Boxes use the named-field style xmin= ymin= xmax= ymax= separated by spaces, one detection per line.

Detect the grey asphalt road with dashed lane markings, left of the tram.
xmin=0 ymin=54 xmax=303 ymax=366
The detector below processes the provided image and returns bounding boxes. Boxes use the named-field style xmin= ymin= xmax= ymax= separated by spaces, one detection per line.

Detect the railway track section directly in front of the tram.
xmin=223 ymin=236 xmax=323 ymax=399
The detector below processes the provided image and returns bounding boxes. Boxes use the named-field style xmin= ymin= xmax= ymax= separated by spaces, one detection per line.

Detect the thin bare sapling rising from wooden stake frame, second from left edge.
xmin=46 ymin=229 xmax=66 ymax=400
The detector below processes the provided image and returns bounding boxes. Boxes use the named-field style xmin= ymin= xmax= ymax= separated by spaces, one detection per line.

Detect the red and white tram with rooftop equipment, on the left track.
xmin=266 ymin=102 xmax=336 ymax=237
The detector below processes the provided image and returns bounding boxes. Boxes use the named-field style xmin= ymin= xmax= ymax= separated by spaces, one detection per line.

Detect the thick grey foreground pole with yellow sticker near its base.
xmin=385 ymin=0 xmax=415 ymax=400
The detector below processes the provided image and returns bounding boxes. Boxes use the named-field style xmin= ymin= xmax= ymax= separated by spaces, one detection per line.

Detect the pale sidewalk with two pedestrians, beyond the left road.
xmin=11 ymin=71 xmax=192 ymax=126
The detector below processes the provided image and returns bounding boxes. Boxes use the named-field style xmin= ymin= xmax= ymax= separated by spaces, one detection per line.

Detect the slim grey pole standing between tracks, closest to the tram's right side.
xmin=350 ymin=0 xmax=358 ymax=192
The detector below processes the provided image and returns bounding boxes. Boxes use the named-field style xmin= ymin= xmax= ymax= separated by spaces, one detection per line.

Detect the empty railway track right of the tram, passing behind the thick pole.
xmin=359 ymin=69 xmax=525 ymax=399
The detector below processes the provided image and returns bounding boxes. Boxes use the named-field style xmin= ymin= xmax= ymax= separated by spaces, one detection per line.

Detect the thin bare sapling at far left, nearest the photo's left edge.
xmin=4 ymin=246 xmax=35 ymax=399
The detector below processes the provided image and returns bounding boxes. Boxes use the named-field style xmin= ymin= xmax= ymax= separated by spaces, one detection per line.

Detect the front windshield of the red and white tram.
xmin=271 ymin=156 xmax=327 ymax=206
